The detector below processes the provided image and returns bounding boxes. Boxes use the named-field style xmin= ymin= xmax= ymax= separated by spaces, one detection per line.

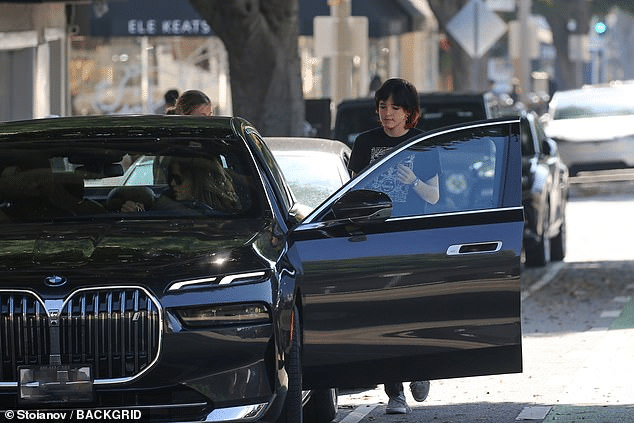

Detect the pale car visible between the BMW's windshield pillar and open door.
xmin=264 ymin=137 xmax=351 ymax=209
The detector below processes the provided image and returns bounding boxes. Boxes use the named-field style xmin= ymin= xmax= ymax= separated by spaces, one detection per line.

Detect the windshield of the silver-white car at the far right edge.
xmin=551 ymin=87 xmax=634 ymax=119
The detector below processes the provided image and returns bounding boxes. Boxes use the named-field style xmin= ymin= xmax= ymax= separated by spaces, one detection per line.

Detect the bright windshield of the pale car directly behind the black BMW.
xmin=273 ymin=151 xmax=345 ymax=208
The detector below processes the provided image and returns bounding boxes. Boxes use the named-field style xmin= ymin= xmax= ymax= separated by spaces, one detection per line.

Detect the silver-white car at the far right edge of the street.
xmin=544 ymin=84 xmax=634 ymax=175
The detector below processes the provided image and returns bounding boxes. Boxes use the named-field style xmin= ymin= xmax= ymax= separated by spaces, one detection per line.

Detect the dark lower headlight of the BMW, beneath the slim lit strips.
xmin=175 ymin=304 xmax=271 ymax=327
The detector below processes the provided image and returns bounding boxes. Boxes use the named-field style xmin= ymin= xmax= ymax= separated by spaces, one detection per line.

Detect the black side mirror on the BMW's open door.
xmin=332 ymin=189 xmax=392 ymax=220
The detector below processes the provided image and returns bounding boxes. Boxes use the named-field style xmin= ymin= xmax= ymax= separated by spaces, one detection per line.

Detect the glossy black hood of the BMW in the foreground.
xmin=0 ymin=219 xmax=275 ymax=296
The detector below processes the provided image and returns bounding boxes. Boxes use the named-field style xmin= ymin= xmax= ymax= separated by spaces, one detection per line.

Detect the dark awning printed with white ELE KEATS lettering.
xmin=90 ymin=0 xmax=213 ymax=37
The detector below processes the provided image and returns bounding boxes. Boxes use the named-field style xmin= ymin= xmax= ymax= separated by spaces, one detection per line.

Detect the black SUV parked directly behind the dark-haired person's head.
xmin=333 ymin=92 xmax=500 ymax=148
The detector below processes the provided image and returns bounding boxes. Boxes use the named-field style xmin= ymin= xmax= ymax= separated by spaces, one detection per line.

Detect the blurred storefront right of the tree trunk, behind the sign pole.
xmin=299 ymin=0 xmax=439 ymax=101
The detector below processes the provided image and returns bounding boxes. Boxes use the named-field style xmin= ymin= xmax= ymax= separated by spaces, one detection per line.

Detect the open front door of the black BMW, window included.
xmin=289 ymin=118 xmax=524 ymax=388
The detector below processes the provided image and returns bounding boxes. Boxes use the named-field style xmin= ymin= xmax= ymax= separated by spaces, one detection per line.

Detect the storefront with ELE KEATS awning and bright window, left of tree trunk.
xmin=69 ymin=0 xmax=231 ymax=115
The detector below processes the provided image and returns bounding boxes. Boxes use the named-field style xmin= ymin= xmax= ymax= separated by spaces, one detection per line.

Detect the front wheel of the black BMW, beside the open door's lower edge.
xmin=277 ymin=308 xmax=303 ymax=423
